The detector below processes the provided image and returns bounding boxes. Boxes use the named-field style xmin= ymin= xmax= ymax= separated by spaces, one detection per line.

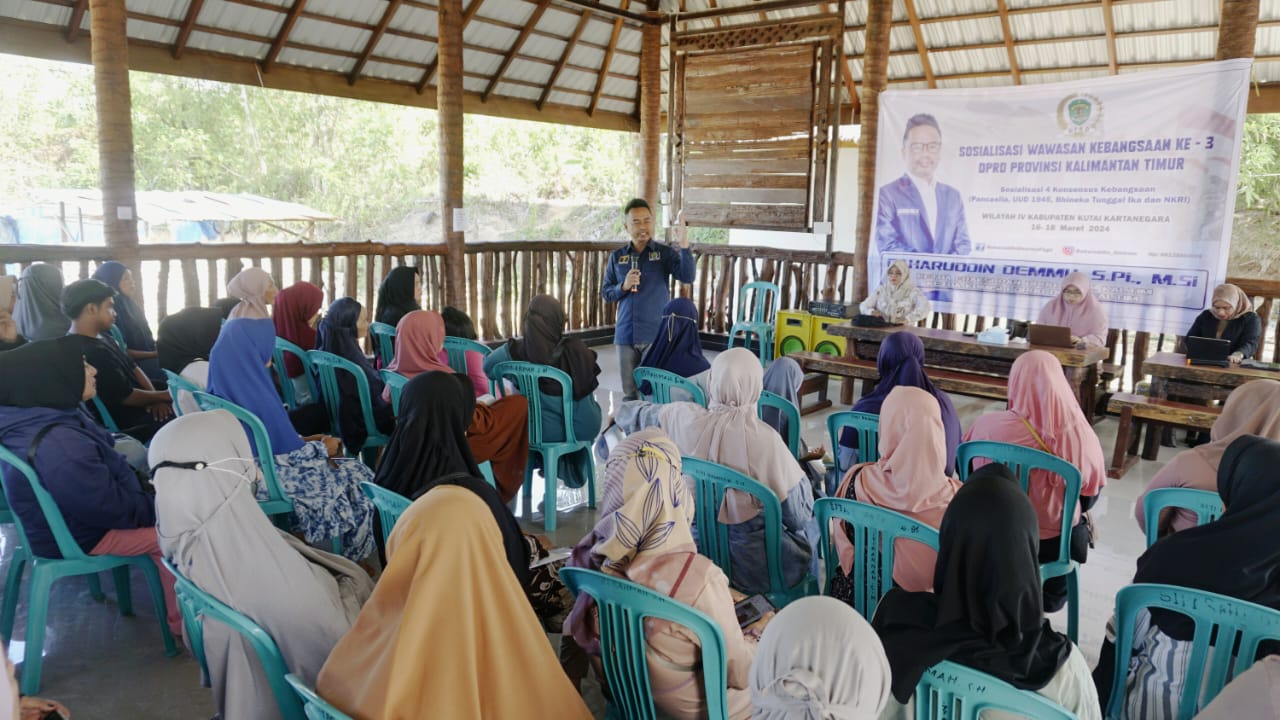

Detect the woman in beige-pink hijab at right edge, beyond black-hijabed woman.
xmin=1133 ymin=380 xmax=1280 ymax=537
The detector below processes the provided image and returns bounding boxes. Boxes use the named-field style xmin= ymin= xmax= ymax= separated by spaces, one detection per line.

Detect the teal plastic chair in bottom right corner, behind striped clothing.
xmin=1106 ymin=584 xmax=1280 ymax=719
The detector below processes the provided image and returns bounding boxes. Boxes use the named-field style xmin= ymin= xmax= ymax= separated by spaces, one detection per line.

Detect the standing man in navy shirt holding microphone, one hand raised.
xmin=600 ymin=197 xmax=696 ymax=400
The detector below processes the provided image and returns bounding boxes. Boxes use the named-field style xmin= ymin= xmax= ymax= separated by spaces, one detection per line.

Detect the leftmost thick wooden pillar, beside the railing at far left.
xmin=88 ymin=0 xmax=142 ymax=272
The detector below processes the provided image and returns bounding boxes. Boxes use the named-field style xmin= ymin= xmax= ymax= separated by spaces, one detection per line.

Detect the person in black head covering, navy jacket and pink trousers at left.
xmin=0 ymin=335 xmax=182 ymax=635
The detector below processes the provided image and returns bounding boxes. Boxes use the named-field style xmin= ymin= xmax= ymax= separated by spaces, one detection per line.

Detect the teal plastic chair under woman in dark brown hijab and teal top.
xmin=489 ymin=360 xmax=595 ymax=533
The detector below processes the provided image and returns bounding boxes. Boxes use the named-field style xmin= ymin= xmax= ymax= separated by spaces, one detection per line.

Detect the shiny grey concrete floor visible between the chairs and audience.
xmin=0 ymin=346 xmax=1180 ymax=720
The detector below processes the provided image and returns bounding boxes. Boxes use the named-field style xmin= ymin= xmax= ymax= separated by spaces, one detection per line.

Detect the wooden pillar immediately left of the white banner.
xmin=852 ymin=0 xmax=893 ymax=301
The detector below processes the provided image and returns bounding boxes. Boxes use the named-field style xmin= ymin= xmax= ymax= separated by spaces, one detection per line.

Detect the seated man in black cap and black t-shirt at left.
xmin=63 ymin=279 xmax=173 ymax=442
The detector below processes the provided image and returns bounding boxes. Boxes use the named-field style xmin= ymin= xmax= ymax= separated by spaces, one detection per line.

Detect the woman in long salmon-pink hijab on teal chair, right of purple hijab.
xmin=964 ymin=350 xmax=1107 ymax=612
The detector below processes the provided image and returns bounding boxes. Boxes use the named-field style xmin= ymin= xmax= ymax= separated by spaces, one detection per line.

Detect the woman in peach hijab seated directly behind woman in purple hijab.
xmin=829 ymin=386 xmax=960 ymax=591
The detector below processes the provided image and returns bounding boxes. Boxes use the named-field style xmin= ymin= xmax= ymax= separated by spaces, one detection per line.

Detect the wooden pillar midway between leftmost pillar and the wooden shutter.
xmin=435 ymin=0 xmax=468 ymax=307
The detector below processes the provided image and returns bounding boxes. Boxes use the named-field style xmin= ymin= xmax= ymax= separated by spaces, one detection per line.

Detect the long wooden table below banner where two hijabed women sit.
xmin=827 ymin=323 xmax=1107 ymax=423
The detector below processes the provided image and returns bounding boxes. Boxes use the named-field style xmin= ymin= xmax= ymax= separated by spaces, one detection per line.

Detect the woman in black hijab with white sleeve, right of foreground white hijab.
xmin=872 ymin=464 xmax=1102 ymax=720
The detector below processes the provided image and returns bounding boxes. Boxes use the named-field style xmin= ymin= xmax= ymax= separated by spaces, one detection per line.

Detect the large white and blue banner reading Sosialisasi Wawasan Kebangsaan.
xmin=868 ymin=60 xmax=1251 ymax=333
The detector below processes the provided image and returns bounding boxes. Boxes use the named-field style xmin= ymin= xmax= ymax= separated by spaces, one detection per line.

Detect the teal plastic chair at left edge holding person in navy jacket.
xmin=0 ymin=447 xmax=178 ymax=694
